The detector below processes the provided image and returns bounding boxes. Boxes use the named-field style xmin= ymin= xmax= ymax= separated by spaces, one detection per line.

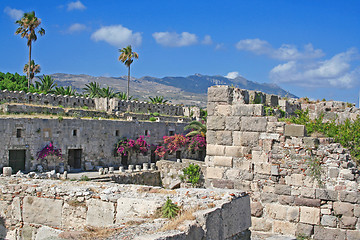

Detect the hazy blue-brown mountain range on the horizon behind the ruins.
xmin=51 ymin=73 xmax=297 ymax=107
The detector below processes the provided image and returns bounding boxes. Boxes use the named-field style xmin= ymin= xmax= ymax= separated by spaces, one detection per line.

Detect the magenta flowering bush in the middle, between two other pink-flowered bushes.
xmin=116 ymin=136 xmax=149 ymax=156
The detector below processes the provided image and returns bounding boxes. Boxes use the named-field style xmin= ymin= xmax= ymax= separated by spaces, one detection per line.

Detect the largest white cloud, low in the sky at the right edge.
xmin=269 ymin=48 xmax=360 ymax=88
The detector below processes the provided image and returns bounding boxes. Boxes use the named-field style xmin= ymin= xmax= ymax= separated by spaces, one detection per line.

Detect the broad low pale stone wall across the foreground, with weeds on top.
xmin=0 ymin=178 xmax=250 ymax=239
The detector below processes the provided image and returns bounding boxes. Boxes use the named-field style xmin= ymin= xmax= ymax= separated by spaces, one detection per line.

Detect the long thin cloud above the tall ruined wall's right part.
xmin=235 ymin=38 xmax=324 ymax=61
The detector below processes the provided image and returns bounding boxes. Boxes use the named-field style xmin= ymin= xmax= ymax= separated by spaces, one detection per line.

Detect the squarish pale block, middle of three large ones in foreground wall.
xmin=86 ymin=199 xmax=115 ymax=227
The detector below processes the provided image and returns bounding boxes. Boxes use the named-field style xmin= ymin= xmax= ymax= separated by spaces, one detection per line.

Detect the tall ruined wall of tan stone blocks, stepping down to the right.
xmin=205 ymin=86 xmax=360 ymax=239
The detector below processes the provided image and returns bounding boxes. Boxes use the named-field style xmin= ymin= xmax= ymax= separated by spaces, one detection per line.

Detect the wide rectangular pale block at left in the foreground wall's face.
xmin=23 ymin=196 xmax=63 ymax=227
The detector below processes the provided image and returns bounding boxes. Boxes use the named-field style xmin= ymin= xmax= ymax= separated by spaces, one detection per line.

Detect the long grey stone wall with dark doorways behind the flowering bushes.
xmin=0 ymin=117 xmax=186 ymax=170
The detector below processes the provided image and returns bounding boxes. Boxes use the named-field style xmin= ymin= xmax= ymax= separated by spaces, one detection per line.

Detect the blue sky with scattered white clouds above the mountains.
xmin=0 ymin=0 xmax=360 ymax=103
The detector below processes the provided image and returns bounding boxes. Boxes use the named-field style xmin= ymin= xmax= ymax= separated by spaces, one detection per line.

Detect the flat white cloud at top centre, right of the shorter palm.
xmin=152 ymin=32 xmax=198 ymax=47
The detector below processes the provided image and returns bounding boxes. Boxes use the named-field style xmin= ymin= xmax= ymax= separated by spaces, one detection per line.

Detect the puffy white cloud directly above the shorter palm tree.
xmin=91 ymin=25 xmax=142 ymax=48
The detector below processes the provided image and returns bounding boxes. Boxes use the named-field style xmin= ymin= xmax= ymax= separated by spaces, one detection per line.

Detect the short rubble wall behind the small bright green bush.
xmin=156 ymin=159 xmax=206 ymax=188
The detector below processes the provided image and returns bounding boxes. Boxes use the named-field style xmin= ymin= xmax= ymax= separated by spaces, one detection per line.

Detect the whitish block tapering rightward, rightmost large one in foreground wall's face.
xmin=116 ymin=198 xmax=163 ymax=223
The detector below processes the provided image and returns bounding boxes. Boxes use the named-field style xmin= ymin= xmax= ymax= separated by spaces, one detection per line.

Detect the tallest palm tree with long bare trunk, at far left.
xmin=15 ymin=11 xmax=45 ymax=89
